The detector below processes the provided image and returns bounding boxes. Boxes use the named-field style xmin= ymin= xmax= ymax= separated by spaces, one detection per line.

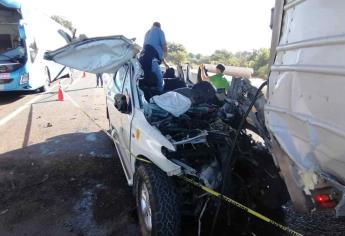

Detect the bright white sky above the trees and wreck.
xmin=23 ymin=0 xmax=274 ymax=55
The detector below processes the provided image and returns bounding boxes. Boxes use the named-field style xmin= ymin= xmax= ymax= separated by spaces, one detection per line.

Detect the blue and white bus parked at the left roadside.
xmin=0 ymin=0 xmax=71 ymax=92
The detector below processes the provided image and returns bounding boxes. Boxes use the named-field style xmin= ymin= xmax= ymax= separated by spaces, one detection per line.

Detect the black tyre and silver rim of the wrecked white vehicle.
xmin=135 ymin=165 xmax=181 ymax=236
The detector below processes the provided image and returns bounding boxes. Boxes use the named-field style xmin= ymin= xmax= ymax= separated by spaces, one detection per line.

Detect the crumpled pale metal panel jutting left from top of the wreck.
xmin=44 ymin=35 xmax=140 ymax=73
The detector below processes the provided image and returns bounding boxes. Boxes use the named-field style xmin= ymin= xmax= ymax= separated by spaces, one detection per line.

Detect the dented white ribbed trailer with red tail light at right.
xmin=265 ymin=0 xmax=345 ymax=216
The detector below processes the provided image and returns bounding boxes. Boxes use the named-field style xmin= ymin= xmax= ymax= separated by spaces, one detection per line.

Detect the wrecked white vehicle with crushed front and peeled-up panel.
xmin=46 ymin=36 xmax=288 ymax=235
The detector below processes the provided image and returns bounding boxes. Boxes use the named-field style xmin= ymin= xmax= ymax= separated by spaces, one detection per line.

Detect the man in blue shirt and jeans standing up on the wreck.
xmin=139 ymin=22 xmax=169 ymax=92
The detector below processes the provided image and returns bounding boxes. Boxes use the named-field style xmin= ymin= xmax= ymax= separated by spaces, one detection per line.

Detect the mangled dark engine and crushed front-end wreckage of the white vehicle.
xmin=144 ymin=77 xmax=289 ymax=231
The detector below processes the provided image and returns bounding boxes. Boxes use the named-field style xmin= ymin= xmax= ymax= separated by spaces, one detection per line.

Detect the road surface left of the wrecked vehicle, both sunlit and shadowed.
xmin=0 ymin=75 xmax=139 ymax=236
